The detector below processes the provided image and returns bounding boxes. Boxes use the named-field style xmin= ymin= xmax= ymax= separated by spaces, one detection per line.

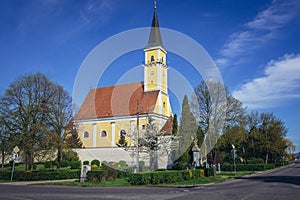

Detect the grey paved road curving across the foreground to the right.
xmin=0 ymin=163 xmax=300 ymax=200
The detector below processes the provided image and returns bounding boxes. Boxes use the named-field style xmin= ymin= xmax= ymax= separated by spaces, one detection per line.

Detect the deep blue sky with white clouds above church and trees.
xmin=0 ymin=0 xmax=300 ymax=151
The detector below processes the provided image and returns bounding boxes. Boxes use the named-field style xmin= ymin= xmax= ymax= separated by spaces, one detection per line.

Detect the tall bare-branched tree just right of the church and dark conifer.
xmin=192 ymin=80 xmax=245 ymax=176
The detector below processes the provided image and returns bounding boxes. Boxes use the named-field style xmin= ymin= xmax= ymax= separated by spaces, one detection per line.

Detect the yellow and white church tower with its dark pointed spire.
xmin=143 ymin=1 xmax=172 ymax=117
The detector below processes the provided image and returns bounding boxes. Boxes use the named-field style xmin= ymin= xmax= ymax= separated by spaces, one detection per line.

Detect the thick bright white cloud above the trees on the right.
xmin=233 ymin=54 xmax=300 ymax=109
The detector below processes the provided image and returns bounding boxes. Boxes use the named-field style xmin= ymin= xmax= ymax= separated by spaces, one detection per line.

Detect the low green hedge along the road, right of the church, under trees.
xmin=221 ymin=164 xmax=275 ymax=171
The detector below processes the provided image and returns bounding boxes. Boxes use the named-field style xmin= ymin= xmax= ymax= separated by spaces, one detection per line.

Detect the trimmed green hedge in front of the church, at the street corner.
xmin=128 ymin=170 xmax=200 ymax=185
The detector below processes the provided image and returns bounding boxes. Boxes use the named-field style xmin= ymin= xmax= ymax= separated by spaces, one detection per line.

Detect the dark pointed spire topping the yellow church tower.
xmin=146 ymin=0 xmax=164 ymax=48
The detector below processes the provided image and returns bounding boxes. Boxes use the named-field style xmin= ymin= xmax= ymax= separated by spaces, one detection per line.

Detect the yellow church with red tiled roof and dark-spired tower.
xmin=73 ymin=4 xmax=172 ymax=149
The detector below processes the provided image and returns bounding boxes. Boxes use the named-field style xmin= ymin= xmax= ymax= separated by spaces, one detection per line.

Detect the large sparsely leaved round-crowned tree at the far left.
xmin=0 ymin=73 xmax=53 ymax=170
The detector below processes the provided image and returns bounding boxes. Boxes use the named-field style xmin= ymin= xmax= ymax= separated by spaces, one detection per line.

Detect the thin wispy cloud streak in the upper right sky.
xmin=218 ymin=0 xmax=300 ymax=65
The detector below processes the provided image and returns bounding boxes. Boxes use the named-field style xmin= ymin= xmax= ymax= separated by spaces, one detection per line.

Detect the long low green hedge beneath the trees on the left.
xmin=0 ymin=170 xmax=80 ymax=181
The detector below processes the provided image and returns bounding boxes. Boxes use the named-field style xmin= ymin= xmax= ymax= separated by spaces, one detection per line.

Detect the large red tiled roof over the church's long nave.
xmin=74 ymin=82 xmax=159 ymax=120
